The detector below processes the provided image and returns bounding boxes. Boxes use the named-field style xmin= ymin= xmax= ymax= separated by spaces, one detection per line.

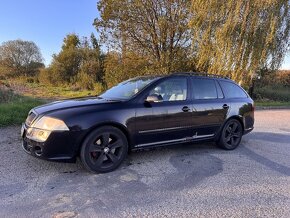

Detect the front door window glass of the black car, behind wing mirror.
xmin=149 ymin=78 xmax=187 ymax=101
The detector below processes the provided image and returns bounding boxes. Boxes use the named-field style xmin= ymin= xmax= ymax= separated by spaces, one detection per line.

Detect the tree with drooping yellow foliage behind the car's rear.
xmin=190 ymin=0 xmax=290 ymax=82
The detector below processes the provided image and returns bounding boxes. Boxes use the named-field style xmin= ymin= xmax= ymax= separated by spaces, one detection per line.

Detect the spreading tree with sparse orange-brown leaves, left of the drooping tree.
xmin=94 ymin=0 xmax=191 ymax=73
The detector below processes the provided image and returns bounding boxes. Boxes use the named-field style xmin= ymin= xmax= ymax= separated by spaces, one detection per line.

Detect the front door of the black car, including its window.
xmin=135 ymin=76 xmax=192 ymax=147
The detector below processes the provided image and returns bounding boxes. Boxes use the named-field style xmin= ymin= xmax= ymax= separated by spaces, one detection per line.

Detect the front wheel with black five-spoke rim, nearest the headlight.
xmin=80 ymin=126 xmax=128 ymax=173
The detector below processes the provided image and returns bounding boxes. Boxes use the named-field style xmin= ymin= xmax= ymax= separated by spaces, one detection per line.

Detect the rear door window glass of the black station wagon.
xmin=192 ymin=78 xmax=217 ymax=99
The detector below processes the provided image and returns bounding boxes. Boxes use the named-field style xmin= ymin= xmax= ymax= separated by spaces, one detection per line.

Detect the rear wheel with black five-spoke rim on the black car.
xmin=217 ymin=119 xmax=243 ymax=150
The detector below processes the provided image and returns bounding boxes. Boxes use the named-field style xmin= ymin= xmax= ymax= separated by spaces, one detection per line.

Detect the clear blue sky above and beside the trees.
xmin=0 ymin=0 xmax=290 ymax=70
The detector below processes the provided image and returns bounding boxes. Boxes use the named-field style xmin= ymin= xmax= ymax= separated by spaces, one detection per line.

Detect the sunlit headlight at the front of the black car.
xmin=32 ymin=116 xmax=69 ymax=131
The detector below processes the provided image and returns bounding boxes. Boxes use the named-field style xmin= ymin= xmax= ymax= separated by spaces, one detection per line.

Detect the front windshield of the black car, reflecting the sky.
xmin=100 ymin=77 xmax=158 ymax=100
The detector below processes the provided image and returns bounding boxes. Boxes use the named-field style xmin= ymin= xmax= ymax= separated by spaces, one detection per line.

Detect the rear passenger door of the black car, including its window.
xmin=191 ymin=77 xmax=229 ymax=138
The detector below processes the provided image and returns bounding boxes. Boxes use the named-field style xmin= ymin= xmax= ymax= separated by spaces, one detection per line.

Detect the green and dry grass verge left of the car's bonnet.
xmin=0 ymin=79 xmax=101 ymax=127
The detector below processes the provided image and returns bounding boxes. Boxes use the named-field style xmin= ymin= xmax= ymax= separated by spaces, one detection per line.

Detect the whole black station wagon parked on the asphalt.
xmin=21 ymin=73 xmax=254 ymax=172
